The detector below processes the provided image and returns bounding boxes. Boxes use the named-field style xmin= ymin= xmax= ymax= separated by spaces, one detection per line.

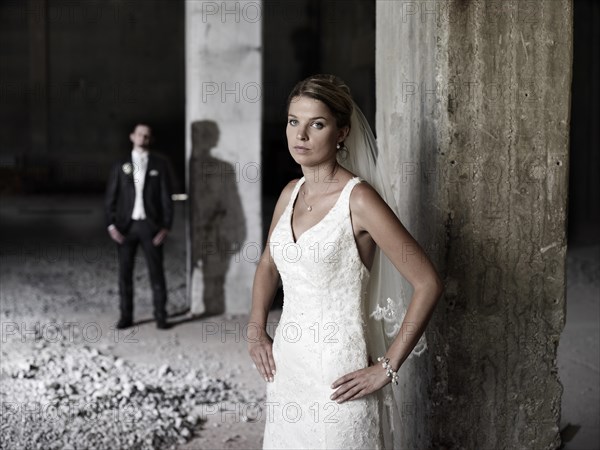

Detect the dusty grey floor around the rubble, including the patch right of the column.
xmin=0 ymin=197 xmax=600 ymax=450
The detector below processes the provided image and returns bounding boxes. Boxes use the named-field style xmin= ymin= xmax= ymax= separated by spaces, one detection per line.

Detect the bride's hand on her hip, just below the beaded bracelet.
xmin=331 ymin=364 xmax=391 ymax=403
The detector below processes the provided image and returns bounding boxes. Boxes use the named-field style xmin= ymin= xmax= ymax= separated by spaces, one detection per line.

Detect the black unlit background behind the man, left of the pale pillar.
xmin=0 ymin=0 xmax=185 ymax=194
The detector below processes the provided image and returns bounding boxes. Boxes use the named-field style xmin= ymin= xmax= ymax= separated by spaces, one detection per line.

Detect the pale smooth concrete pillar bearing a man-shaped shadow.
xmin=186 ymin=0 xmax=262 ymax=313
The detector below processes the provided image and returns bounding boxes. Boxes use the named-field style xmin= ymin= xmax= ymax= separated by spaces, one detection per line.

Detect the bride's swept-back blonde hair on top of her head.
xmin=287 ymin=74 xmax=354 ymax=132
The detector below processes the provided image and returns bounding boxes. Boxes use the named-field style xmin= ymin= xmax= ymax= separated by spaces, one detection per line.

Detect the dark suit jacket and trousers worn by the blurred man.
xmin=105 ymin=153 xmax=173 ymax=321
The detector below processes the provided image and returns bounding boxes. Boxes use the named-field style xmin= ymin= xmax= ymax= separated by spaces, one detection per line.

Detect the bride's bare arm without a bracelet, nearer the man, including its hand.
xmin=248 ymin=180 xmax=298 ymax=381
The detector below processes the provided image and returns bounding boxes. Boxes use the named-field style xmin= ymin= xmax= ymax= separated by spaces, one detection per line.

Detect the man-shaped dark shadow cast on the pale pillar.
xmin=190 ymin=120 xmax=246 ymax=316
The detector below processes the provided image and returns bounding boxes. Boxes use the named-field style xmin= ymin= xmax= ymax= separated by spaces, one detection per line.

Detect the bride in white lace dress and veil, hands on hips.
xmin=248 ymin=75 xmax=442 ymax=449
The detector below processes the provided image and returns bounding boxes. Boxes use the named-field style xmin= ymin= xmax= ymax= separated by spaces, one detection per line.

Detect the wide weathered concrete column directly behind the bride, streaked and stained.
xmin=377 ymin=0 xmax=572 ymax=449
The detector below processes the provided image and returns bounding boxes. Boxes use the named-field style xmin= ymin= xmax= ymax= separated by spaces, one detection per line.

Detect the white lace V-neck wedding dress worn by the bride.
xmin=263 ymin=177 xmax=383 ymax=449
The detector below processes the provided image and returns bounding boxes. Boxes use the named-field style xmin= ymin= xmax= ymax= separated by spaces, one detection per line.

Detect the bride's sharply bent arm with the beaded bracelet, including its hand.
xmin=331 ymin=183 xmax=443 ymax=402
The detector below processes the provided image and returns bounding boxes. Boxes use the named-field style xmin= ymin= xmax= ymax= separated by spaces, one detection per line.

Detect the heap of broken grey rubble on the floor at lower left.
xmin=0 ymin=341 xmax=262 ymax=450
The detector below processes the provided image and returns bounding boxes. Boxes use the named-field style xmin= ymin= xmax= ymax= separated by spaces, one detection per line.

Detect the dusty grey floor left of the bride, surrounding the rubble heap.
xmin=0 ymin=198 xmax=277 ymax=449
